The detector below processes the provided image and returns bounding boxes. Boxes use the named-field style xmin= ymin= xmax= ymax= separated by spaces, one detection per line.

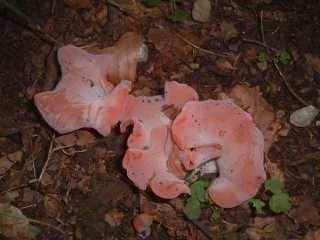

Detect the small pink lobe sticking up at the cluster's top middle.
xmin=164 ymin=81 xmax=199 ymax=108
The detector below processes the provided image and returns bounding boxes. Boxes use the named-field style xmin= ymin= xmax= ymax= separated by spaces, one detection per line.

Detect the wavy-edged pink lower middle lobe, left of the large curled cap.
xmin=123 ymin=125 xmax=189 ymax=199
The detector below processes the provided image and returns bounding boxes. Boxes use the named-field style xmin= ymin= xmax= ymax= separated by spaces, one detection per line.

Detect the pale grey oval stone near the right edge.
xmin=290 ymin=105 xmax=320 ymax=127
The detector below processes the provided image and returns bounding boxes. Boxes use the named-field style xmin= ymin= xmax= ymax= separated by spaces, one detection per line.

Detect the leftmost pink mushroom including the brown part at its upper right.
xmin=34 ymin=33 xmax=144 ymax=135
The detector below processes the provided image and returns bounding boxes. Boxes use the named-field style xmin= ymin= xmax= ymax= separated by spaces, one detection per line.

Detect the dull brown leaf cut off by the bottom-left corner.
xmin=0 ymin=203 xmax=35 ymax=240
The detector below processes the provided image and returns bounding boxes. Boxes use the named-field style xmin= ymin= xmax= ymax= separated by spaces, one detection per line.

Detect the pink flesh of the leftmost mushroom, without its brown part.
xmin=35 ymin=45 xmax=131 ymax=135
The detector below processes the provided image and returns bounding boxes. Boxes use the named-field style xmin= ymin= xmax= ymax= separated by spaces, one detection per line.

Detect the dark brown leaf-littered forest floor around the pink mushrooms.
xmin=0 ymin=0 xmax=320 ymax=240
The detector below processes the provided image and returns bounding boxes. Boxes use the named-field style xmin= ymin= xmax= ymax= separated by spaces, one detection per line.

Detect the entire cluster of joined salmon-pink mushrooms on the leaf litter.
xmin=34 ymin=33 xmax=266 ymax=208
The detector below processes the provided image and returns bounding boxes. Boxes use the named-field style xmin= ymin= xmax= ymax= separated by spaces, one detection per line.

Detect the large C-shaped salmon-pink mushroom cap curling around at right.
xmin=172 ymin=100 xmax=266 ymax=208
